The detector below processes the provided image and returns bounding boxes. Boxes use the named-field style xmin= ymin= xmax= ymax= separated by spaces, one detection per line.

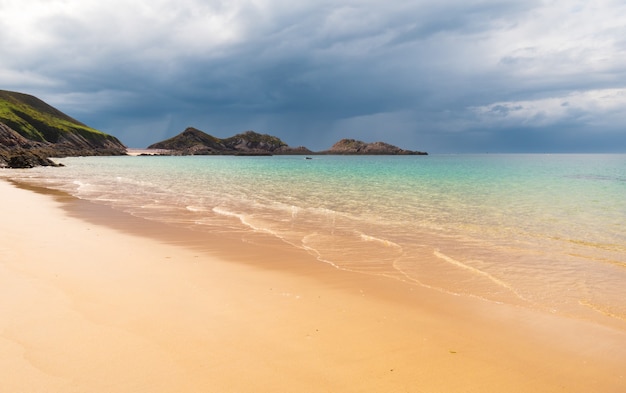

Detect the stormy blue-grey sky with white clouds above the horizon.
xmin=0 ymin=0 xmax=626 ymax=153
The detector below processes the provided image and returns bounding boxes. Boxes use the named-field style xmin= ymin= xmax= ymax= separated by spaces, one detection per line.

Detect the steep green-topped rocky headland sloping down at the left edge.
xmin=0 ymin=90 xmax=126 ymax=167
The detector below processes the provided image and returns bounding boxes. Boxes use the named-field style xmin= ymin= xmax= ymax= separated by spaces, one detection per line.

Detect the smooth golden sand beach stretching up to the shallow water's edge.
xmin=0 ymin=181 xmax=626 ymax=393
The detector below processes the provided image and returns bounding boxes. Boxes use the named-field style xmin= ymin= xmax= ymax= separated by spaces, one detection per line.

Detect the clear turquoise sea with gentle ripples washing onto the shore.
xmin=0 ymin=154 xmax=626 ymax=328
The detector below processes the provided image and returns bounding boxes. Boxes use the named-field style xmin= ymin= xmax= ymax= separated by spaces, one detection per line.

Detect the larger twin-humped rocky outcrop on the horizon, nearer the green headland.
xmin=148 ymin=127 xmax=312 ymax=155
